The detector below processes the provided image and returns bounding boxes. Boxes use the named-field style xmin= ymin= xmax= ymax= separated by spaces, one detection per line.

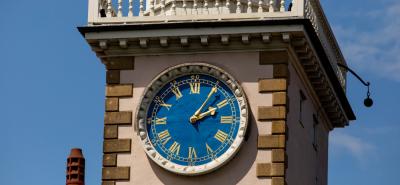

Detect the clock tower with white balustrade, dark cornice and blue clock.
xmin=79 ymin=0 xmax=355 ymax=185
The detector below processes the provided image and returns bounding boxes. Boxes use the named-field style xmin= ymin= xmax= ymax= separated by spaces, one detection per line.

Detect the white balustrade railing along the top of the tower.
xmin=88 ymin=0 xmax=346 ymax=88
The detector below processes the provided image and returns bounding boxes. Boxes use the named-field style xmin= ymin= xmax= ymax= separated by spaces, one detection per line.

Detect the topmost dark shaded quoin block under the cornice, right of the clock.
xmin=260 ymin=51 xmax=289 ymax=65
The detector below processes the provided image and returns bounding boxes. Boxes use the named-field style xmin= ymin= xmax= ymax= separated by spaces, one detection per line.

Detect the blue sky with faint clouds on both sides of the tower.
xmin=0 ymin=0 xmax=400 ymax=185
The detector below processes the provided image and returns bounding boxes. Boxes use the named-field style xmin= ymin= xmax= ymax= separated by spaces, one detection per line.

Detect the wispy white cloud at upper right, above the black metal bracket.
xmin=333 ymin=1 xmax=400 ymax=82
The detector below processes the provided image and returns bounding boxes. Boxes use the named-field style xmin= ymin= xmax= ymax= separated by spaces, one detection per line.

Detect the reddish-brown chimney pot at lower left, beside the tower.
xmin=66 ymin=148 xmax=85 ymax=185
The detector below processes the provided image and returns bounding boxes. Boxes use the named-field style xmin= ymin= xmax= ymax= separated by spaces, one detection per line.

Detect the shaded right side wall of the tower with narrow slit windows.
xmin=286 ymin=64 xmax=329 ymax=185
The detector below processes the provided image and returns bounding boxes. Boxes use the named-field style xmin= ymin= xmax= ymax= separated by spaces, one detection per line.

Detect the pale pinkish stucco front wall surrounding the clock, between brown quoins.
xmin=117 ymin=52 xmax=273 ymax=185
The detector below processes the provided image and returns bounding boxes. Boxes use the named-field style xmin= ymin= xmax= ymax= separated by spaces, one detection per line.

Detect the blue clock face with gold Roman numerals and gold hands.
xmin=147 ymin=74 xmax=240 ymax=166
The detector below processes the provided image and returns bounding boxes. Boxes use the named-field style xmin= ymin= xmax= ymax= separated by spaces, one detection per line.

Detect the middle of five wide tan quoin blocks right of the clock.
xmin=258 ymin=106 xmax=286 ymax=121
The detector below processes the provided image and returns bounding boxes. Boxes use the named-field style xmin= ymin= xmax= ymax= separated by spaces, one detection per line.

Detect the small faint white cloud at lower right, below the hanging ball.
xmin=330 ymin=131 xmax=376 ymax=163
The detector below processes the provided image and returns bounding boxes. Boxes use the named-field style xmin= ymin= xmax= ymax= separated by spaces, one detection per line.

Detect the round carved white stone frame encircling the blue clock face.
xmin=136 ymin=63 xmax=249 ymax=176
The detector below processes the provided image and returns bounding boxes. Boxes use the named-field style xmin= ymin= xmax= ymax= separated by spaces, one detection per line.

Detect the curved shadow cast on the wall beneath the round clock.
xmin=147 ymin=111 xmax=258 ymax=185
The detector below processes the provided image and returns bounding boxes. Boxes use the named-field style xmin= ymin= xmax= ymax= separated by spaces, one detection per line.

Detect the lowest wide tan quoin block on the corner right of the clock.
xmin=256 ymin=163 xmax=285 ymax=177
